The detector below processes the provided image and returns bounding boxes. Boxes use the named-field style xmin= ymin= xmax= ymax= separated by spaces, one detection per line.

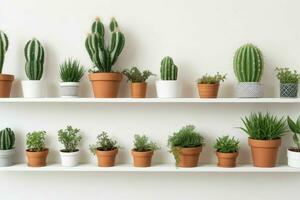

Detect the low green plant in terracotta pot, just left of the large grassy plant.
xmin=214 ymin=135 xmax=240 ymax=167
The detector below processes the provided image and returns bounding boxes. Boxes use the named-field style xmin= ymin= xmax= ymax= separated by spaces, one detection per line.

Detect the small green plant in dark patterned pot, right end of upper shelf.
xmin=275 ymin=68 xmax=300 ymax=97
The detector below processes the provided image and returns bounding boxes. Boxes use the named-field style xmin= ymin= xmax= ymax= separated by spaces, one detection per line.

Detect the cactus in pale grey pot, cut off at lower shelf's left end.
xmin=0 ymin=128 xmax=15 ymax=167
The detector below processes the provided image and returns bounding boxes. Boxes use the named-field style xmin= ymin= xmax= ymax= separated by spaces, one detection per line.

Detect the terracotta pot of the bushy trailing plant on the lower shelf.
xmin=178 ymin=147 xmax=202 ymax=167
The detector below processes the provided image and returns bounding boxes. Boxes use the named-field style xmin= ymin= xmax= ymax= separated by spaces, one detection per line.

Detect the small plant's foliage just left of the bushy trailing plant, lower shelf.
xmin=133 ymin=135 xmax=159 ymax=152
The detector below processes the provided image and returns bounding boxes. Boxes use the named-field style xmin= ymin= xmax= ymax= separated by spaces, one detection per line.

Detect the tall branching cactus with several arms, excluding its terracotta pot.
xmin=85 ymin=18 xmax=125 ymax=72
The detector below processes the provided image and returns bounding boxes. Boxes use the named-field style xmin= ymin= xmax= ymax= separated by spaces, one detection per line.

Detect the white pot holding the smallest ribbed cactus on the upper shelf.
xmin=156 ymin=80 xmax=181 ymax=98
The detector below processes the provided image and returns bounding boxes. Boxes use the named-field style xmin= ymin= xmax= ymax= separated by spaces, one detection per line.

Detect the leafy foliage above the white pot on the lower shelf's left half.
xmin=58 ymin=126 xmax=82 ymax=152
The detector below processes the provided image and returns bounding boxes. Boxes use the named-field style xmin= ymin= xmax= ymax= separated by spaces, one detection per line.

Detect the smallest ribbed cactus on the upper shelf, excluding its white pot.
xmin=160 ymin=56 xmax=178 ymax=80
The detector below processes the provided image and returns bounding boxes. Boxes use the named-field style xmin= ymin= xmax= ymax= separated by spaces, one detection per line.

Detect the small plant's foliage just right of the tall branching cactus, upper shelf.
xmin=123 ymin=67 xmax=155 ymax=83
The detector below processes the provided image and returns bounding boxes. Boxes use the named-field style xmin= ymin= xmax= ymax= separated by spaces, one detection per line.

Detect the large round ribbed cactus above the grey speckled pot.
xmin=233 ymin=44 xmax=264 ymax=82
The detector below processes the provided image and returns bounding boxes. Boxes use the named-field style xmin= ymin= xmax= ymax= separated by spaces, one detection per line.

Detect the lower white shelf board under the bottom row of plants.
xmin=0 ymin=163 xmax=300 ymax=173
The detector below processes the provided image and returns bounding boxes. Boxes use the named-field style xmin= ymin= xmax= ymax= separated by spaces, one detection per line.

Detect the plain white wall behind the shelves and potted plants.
xmin=0 ymin=0 xmax=300 ymax=200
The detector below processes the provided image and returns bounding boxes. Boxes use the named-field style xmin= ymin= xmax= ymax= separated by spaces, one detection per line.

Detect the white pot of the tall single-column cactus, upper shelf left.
xmin=22 ymin=80 xmax=44 ymax=98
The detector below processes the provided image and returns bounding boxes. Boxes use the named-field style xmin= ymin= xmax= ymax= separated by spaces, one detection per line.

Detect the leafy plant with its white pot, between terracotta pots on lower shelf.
xmin=58 ymin=126 xmax=82 ymax=167
